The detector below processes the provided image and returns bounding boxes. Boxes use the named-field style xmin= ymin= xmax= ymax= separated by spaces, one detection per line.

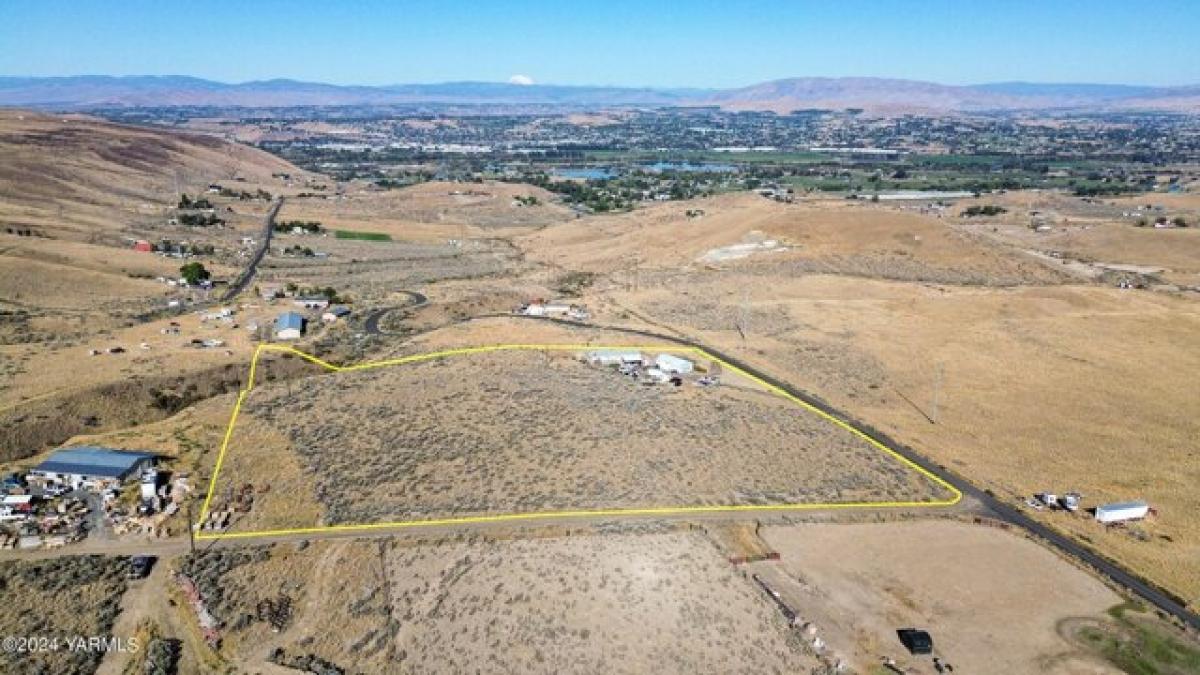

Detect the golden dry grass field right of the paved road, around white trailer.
xmin=544 ymin=193 xmax=1200 ymax=603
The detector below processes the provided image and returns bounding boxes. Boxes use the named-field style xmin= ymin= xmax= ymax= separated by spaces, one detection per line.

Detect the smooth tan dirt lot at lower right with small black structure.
xmin=751 ymin=520 xmax=1121 ymax=675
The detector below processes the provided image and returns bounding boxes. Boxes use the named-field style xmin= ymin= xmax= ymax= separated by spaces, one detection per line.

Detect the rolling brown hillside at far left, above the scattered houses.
xmin=0 ymin=110 xmax=306 ymax=336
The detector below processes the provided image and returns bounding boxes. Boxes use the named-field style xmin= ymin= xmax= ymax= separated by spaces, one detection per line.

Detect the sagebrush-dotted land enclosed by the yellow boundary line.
xmin=213 ymin=352 xmax=947 ymax=528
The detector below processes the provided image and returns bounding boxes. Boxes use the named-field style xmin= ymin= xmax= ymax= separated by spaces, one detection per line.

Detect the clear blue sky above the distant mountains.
xmin=0 ymin=0 xmax=1200 ymax=88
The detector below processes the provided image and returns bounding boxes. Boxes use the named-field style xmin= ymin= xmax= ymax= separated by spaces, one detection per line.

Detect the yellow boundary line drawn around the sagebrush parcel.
xmin=196 ymin=344 xmax=962 ymax=539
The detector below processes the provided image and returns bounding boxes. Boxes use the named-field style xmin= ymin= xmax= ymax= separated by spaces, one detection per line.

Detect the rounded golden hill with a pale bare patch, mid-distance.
xmin=516 ymin=193 xmax=1068 ymax=286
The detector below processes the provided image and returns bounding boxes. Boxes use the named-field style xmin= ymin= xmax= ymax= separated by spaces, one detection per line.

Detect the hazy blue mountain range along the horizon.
xmin=0 ymin=76 xmax=1200 ymax=113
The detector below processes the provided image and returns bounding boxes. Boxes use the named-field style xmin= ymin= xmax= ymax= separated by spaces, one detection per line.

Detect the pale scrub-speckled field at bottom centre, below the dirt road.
xmin=177 ymin=532 xmax=817 ymax=673
